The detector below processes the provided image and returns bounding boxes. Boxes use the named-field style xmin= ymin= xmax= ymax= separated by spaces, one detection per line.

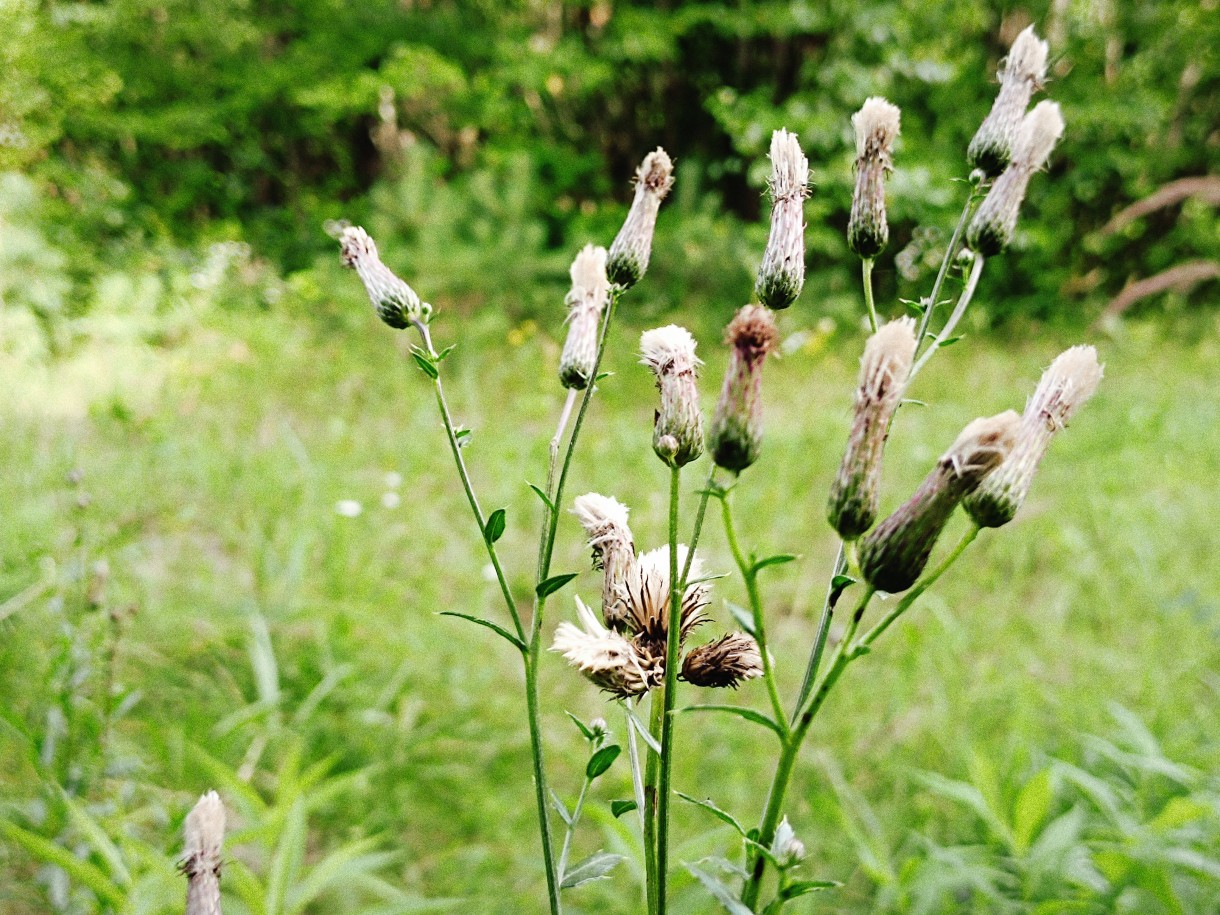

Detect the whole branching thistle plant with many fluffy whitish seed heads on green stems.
xmin=342 ymin=29 xmax=1102 ymax=915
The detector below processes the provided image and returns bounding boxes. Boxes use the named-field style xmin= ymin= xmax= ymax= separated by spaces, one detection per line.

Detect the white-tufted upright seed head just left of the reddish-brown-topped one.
xmin=639 ymin=325 xmax=703 ymax=467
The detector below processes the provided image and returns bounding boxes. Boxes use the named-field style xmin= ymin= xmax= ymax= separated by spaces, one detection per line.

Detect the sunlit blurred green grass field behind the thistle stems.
xmin=0 ymin=302 xmax=1220 ymax=914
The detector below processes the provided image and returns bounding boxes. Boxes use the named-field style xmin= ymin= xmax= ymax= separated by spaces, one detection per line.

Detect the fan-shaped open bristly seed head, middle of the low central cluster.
xmin=619 ymin=544 xmax=711 ymax=660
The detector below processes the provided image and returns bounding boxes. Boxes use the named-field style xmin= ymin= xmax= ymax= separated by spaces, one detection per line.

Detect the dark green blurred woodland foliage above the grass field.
xmin=0 ymin=0 xmax=1220 ymax=326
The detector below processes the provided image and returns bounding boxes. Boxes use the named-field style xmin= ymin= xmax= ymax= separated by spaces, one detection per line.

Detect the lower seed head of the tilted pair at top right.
xmin=966 ymin=101 xmax=1064 ymax=256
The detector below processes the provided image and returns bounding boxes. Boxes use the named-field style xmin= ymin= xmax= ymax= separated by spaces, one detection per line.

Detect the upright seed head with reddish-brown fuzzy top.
xmin=710 ymin=305 xmax=780 ymax=473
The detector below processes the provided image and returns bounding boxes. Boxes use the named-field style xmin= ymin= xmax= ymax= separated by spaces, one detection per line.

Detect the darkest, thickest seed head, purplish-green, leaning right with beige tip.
xmin=860 ymin=410 xmax=1021 ymax=594
